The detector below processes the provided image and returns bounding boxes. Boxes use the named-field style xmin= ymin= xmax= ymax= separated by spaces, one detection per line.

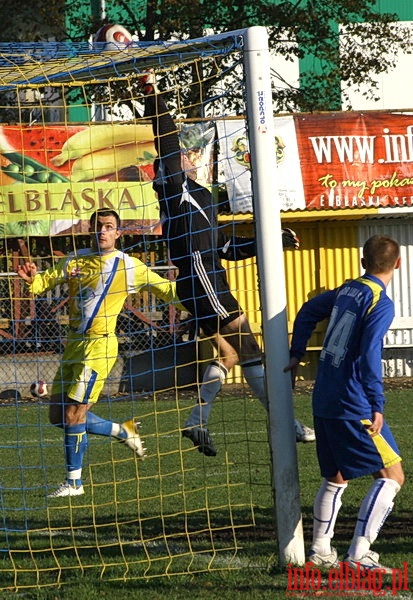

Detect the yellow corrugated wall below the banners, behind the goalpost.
xmin=219 ymin=220 xmax=361 ymax=383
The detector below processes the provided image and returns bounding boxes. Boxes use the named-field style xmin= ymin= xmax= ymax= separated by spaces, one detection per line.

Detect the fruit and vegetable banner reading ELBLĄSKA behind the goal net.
xmin=0 ymin=122 xmax=215 ymax=237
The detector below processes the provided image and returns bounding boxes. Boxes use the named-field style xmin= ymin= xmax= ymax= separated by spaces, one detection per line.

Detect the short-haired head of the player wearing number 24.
xmin=361 ymin=235 xmax=400 ymax=275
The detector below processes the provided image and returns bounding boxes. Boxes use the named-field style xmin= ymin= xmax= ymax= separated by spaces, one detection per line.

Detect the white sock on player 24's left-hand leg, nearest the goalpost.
xmin=311 ymin=479 xmax=347 ymax=556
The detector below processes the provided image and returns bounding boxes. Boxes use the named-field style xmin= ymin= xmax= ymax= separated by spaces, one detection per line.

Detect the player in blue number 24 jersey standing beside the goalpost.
xmin=285 ymin=235 xmax=404 ymax=572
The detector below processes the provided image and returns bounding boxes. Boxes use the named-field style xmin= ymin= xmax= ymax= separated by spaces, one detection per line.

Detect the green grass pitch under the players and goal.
xmin=0 ymin=388 xmax=413 ymax=600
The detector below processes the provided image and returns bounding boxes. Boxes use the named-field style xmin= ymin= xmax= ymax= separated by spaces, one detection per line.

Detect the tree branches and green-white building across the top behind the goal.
xmin=0 ymin=0 xmax=412 ymax=111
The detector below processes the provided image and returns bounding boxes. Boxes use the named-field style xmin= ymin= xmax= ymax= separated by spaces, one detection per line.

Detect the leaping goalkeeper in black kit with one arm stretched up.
xmin=141 ymin=75 xmax=314 ymax=456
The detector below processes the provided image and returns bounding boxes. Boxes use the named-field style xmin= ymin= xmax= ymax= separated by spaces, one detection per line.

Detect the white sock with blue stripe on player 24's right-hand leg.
xmin=348 ymin=478 xmax=400 ymax=560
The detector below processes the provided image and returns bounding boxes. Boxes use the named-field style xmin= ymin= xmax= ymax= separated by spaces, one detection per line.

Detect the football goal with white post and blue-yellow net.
xmin=0 ymin=27 xmax=304 ymax=595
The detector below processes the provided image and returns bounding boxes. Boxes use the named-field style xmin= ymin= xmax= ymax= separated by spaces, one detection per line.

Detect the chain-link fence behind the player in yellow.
xmin=0 ymin=237 xmax=193 ymax=389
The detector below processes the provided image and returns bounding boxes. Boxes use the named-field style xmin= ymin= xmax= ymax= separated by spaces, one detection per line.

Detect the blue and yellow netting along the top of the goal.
xmin=0 ymin=29 xmax=248 ymax=90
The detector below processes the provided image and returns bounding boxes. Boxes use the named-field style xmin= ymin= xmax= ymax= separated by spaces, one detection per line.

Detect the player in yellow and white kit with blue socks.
xmin=18 ymin=209 xmax=182 ymax=498
